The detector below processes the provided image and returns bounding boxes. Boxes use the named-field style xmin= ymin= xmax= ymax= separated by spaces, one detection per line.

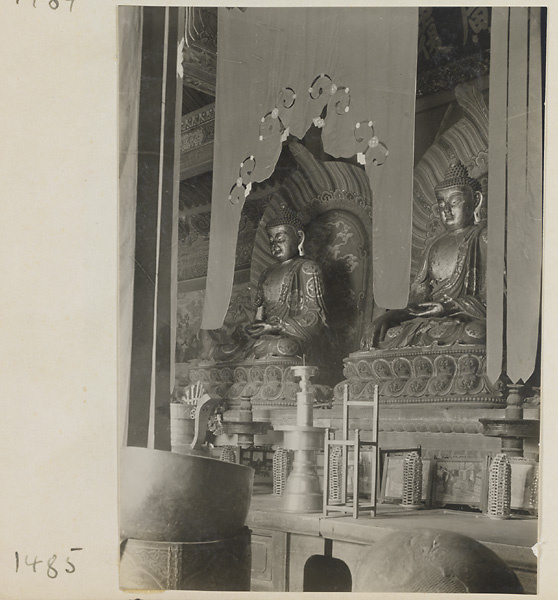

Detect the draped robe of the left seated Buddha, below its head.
xmin=213 ymin=257 xmax=329 ymax=362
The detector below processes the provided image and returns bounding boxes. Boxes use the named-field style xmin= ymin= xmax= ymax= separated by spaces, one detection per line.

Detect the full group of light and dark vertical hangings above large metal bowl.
xmin=118 ymin=7 xmax=185 ymax=450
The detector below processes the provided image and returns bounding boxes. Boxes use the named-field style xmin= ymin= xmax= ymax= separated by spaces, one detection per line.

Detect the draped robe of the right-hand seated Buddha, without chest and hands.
xmin=380 ymin=225 xmax=487 ymax=349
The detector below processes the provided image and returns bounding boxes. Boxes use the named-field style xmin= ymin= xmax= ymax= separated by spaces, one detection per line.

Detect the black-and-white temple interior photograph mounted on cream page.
xmin=118 ymin=6 xmax=547 ymax=594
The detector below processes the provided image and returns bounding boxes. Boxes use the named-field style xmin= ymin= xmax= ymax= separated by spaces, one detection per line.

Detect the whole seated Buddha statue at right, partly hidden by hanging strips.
xmin=361 ymin=160 xmax=487 ymax=350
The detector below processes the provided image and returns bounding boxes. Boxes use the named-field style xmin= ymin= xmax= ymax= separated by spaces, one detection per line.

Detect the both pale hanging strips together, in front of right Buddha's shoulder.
xmin=487 ymin=7 xmax=543 ymax=383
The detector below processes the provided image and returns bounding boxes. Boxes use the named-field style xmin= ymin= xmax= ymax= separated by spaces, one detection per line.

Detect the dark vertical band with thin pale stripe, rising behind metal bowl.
xmin=128 ymin=7 xmax=184 ymax=449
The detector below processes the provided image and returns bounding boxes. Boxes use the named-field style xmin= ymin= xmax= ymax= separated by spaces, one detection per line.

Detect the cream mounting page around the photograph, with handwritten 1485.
xmin=0 ymin=0 xmax=558 ymax=600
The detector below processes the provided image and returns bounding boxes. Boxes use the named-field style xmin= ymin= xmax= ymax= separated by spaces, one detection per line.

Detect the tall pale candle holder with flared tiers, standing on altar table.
xmin=280 ymin=365 xmax=324 ymax=513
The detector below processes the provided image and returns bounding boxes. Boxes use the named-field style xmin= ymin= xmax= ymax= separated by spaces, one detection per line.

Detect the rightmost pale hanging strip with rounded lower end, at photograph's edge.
xmin=507 ymin=7 xmax=543 ymax=383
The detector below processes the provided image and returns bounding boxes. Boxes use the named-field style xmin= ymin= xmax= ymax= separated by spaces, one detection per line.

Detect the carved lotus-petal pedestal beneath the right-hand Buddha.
xmin=334 ymin=346 xmax=506 ymax=408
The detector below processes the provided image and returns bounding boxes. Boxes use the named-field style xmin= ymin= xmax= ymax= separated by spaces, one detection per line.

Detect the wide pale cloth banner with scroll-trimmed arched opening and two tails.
xmin=202 ymin=7 xmax=418 ymax=329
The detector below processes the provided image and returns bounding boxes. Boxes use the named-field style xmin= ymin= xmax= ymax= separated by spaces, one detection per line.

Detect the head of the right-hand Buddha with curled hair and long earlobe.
xmin=434 ymin=159 xmax=482 ymax=231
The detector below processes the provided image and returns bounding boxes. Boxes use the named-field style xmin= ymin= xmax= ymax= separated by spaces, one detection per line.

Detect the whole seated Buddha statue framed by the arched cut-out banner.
xmin=200 ymin=204 xmax=328 ymax=361
